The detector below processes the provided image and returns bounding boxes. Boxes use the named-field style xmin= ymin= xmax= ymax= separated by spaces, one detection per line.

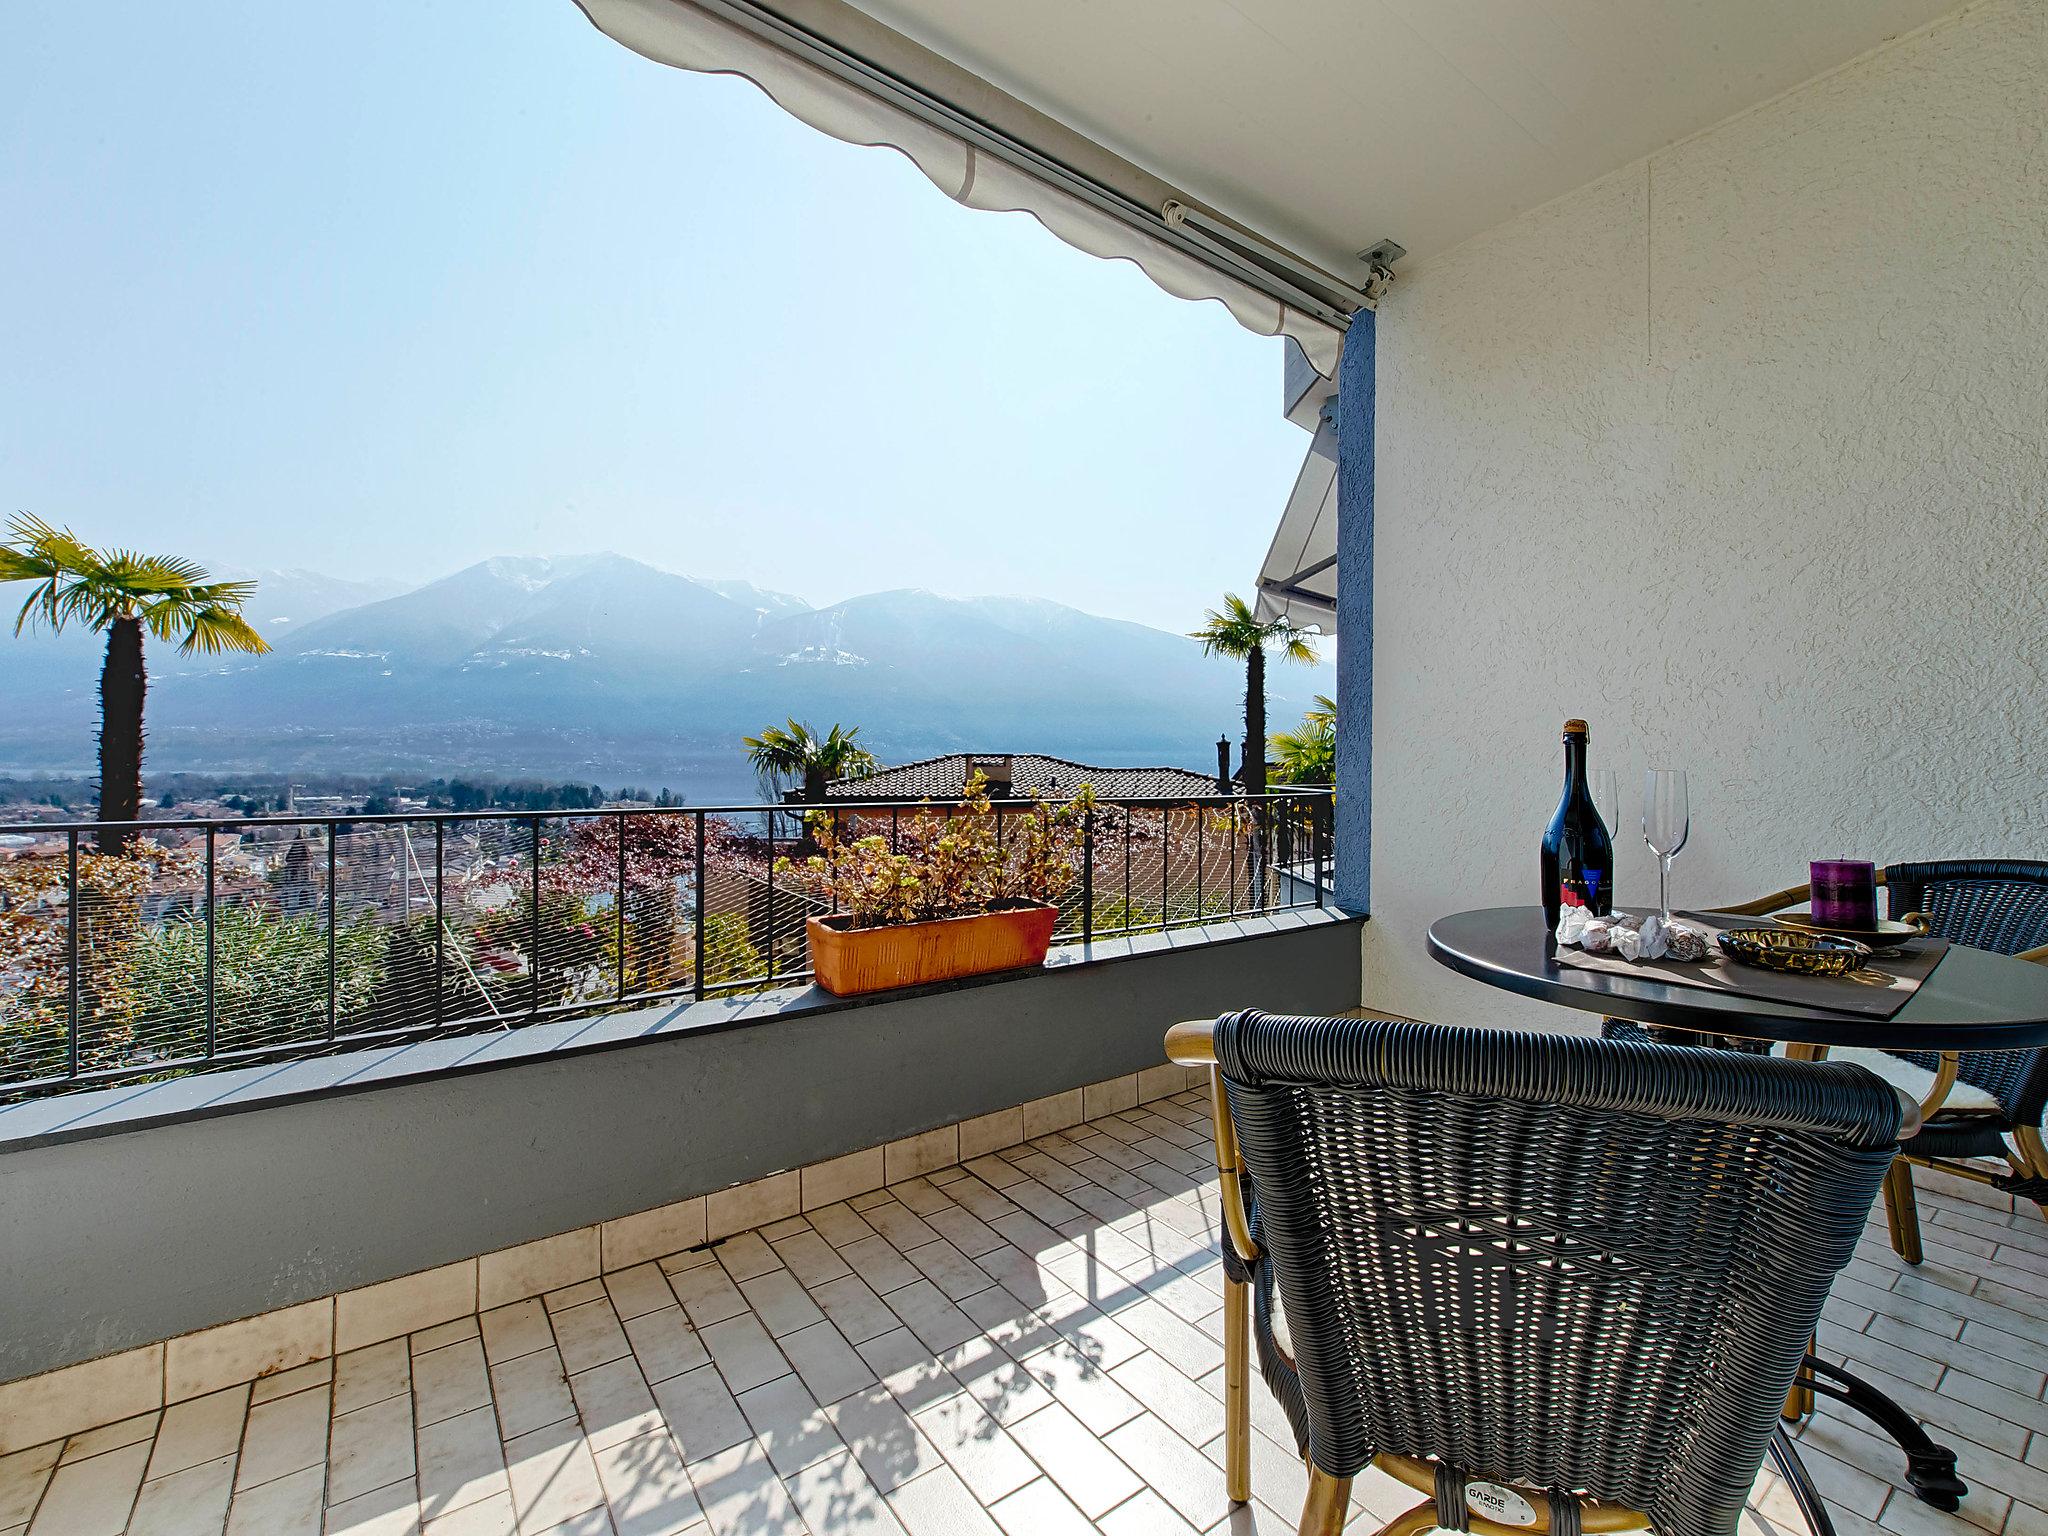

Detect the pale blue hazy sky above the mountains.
xmin=0 ymin=0 xmax=1307 ymax=629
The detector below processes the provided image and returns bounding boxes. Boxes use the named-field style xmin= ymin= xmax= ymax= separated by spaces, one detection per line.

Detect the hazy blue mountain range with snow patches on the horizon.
xmin=0 ymin=555 xmax=1329 ymax=803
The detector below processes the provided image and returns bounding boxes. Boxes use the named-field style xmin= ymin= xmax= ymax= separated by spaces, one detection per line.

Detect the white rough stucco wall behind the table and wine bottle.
xmin=1364 ymin=0 xmax=2048 ymax=1024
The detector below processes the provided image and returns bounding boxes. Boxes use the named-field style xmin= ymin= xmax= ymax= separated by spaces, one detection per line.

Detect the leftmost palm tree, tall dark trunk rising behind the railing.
xmin=0 ymin=512 xmax=270 ymax=854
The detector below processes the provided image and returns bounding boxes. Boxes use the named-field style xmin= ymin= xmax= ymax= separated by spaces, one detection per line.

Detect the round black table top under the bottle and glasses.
xmin=1430 ymin=907 xmax=2048 ymax=1051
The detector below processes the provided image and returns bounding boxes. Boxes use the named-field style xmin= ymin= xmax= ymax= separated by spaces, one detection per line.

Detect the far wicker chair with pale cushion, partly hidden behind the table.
xmin=1726 ymin=858 xmax=2048 ymax=1264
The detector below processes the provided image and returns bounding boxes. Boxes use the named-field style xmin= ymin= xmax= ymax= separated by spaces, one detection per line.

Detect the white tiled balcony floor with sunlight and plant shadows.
xmin=12 ymin=1094 xmax=2048 ymax=1536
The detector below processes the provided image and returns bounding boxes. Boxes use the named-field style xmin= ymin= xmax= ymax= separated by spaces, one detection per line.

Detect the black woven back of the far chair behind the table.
xmin=1884 ymin=858 xmax=2048 ymax=1124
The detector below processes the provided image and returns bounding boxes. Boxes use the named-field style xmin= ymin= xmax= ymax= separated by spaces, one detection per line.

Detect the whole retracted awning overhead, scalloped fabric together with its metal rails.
xmin=575 ymin=0 xmax=1372 ymax=375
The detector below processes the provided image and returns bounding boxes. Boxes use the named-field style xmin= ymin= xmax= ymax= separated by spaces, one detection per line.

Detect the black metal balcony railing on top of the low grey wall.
xmin=0 ymin=788 xmax=1331 ymax=1100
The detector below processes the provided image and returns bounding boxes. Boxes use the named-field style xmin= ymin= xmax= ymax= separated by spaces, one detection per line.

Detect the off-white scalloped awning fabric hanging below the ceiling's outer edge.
xmin=575 ymin=0 xmax=1343 ymax=377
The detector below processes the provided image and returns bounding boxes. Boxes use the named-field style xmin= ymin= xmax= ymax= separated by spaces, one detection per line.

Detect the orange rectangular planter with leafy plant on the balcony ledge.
xmin=776 ymin=774 xmax=1096 ymax=997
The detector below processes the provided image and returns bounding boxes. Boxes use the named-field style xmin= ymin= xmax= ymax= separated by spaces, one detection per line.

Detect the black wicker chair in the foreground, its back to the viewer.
xmin=1167 ymin=1012 xmax=1917 ymax=1536
